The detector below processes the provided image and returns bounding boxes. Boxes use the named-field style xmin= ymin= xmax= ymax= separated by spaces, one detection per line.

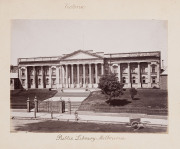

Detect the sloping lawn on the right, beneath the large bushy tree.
xmin=79 ymin=89 xmax=168 ymax=115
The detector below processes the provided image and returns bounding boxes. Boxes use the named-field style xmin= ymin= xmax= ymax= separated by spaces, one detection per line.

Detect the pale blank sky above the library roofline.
xmin=11 ymin=20 xmax=167 ymax=66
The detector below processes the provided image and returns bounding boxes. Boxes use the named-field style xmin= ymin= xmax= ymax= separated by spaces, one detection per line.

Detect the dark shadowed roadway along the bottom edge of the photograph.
xmin=11 ymin=119 xmax=167 ymax=133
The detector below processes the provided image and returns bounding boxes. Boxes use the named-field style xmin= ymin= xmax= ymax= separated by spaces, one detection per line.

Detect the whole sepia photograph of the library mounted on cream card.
xmin=9 ymin=19 xmax=169 ymax=133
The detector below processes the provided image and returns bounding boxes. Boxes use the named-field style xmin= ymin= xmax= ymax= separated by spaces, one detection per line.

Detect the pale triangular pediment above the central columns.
xmin=62 ymin=50 xmax=101 ymax=60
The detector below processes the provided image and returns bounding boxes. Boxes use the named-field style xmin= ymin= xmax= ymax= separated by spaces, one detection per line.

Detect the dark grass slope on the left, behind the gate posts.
xmin=10 ymin=89 xmax=57 ymax=107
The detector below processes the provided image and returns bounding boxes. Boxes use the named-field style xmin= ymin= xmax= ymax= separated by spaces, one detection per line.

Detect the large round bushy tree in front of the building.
xmin=98 ymin=73 xmax=124 ymax=100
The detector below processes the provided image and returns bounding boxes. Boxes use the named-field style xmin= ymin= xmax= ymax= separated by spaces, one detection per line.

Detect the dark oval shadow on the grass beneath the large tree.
xmin=106 ymin=99 xmax=131 ymax=106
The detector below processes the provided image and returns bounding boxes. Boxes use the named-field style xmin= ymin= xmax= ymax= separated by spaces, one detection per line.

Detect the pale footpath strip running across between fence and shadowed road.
xmin=11 ymin=109 xmax=168 ymax=127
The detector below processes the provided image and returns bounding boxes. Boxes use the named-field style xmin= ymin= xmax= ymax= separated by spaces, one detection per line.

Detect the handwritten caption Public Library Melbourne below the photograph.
xmin=56 ymin=134 xmax=125 ymax=142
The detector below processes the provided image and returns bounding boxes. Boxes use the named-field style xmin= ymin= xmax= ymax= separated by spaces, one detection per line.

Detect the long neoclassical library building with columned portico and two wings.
xmin=18 ymin=50 xmax=161 ymax=89
